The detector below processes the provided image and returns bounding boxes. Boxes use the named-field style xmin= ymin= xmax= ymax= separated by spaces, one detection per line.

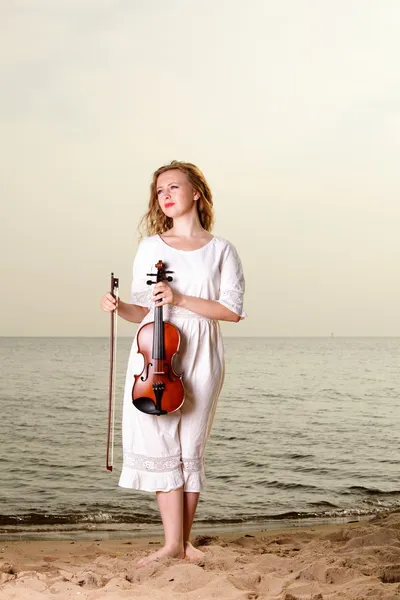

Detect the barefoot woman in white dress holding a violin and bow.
xmin=101 ymin=161 xmax=246 ymax=567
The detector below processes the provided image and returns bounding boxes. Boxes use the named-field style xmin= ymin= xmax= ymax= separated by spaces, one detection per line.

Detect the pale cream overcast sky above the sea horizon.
xmin=0 ymin=0 xmax=400 ymax=336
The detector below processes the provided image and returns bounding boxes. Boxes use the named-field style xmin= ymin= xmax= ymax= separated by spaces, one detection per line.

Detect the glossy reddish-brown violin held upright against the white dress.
xmin=132 ymin=260 xmax=185 ymax=415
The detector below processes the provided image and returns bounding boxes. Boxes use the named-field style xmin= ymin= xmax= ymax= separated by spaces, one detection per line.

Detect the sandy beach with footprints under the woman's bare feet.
xmin=0 ymin=512 xmax=400 ymax=600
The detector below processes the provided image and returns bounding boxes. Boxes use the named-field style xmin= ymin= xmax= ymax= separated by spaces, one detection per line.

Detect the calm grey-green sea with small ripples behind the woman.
xmin=0 ymin=337 xmax=400 ymax=540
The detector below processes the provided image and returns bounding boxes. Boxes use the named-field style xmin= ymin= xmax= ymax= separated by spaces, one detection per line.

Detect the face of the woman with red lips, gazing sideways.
xmin=157 ymin=169 xmax=198 ymax=219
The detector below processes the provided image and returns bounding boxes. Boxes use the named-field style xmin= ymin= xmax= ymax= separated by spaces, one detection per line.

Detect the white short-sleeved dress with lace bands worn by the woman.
xmin=119 ymin=235 xmax=246 ymax=492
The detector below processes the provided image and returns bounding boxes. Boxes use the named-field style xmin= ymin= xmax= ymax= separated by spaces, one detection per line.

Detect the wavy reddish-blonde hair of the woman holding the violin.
xmin=139 ymin=160 xmax=214 ymax=237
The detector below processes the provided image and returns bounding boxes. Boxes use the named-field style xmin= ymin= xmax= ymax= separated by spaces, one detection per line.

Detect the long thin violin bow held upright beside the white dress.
xmin=106 ymin=273 xmax=119 ymax=471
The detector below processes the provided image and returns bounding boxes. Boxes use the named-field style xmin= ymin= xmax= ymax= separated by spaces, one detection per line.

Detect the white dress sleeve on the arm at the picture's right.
xmin=218 ymin=244 xmax=247 ymax=319
